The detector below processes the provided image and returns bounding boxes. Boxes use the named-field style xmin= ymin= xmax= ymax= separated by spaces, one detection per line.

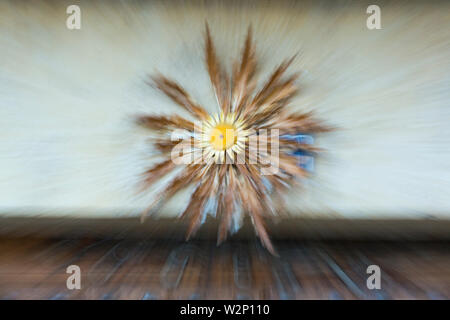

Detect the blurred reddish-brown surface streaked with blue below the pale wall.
xmin=0 ymin=238 xmax=450 ymax=299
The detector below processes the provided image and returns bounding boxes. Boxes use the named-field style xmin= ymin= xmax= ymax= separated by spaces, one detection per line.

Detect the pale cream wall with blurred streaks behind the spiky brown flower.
xmin=0 ymin=1 xmax=450 ymax=218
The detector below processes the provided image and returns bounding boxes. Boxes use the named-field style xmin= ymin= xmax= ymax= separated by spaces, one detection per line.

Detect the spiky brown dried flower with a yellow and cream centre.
xmin=138 ymin=24 xmax=329 ymax=253
